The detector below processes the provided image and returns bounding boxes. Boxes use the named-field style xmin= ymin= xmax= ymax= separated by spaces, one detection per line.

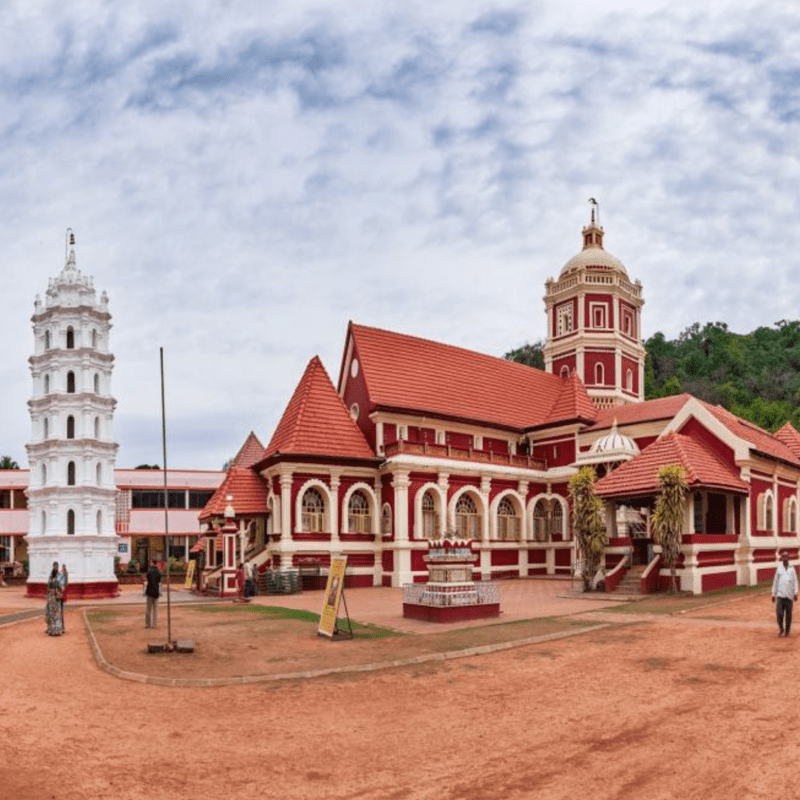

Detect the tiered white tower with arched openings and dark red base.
xmin=26 ymin=230 xmax=119 ymax=598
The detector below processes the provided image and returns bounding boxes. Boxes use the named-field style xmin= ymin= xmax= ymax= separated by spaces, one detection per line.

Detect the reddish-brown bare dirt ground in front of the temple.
xmin=0 ymin=592 xmax=800 ymax=800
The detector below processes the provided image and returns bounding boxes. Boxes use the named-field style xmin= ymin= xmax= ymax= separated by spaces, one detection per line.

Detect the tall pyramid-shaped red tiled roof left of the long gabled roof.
xmin=264 ymin=356 xmax=375 ymax=460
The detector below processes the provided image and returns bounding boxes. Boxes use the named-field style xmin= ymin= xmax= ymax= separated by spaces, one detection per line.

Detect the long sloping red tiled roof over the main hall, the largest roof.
xmin=340 ymin=322 xmax=580 ymax=430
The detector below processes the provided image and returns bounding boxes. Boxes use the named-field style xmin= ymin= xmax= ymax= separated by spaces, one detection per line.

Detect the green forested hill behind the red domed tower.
xmin=504 ymin=320 xmax=800 ymax=431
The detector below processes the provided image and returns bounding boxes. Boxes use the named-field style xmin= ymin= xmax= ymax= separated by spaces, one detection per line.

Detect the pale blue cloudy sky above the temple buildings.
xmin=0 ymin=0 xmax=800 ymax=469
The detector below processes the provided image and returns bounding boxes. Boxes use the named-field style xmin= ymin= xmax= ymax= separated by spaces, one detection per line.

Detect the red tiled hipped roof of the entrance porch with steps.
xmin=594 ymin=431 xmax=749 ymax=498
